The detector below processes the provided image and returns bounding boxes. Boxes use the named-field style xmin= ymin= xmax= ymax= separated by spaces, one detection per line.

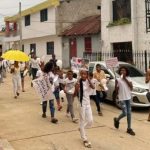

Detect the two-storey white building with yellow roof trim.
xmin=4 ymin=1 xmax=62 ymax=60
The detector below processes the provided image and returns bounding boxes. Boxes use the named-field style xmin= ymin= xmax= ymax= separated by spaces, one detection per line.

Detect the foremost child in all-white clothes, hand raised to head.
xmin=79 ymin=68 xmax=94 ymax=148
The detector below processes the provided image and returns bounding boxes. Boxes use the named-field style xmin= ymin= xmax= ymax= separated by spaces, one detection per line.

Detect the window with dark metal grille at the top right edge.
xmin=145 ymin=0 xmax=150 ymax=32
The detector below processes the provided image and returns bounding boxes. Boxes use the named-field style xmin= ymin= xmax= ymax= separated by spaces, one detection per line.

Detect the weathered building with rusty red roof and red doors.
xmin=57 ymin=0 xmax=101 ymax=68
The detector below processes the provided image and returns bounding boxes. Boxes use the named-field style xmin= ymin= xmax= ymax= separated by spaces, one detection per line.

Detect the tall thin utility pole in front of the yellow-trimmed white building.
xmin=19 ymin=2 xmax=22 ymax=50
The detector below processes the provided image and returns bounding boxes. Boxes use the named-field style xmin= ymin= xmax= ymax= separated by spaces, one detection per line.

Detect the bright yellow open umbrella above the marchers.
xmin=1 ymin=50 xmax=30 ymax=62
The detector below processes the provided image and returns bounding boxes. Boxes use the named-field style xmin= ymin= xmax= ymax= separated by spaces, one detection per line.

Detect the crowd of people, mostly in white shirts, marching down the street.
xmin=0 ymin=53 xmax=150 ymax=148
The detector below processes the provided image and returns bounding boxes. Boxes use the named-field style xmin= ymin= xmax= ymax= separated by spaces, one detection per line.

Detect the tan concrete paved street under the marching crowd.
xmin=0 ymin=75 xmax=150 ymax=150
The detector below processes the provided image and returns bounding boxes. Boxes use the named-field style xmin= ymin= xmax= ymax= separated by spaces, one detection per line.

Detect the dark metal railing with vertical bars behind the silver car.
xmin=83 ymin=50 xmax=150 ymax=72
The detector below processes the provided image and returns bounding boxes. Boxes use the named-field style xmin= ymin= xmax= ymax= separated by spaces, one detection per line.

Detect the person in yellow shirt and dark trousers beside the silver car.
xmin=93 ymin=64 xmax=106 ymax=116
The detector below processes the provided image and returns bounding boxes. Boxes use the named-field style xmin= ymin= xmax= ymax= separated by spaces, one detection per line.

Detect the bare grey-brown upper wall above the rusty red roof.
xmin=56 ymin=0 xmax=101 ymax=34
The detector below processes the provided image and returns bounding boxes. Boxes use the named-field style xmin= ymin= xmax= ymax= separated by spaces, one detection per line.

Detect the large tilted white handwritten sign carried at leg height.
xmin=32 ymin=76 xmax=54 ymax=101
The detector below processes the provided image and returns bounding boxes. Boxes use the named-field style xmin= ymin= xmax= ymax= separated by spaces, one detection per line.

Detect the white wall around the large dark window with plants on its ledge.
xmin=101 ymin=0 xmax=137 ymax=51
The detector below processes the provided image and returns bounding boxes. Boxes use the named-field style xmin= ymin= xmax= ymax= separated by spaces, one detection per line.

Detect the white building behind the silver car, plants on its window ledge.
xmin=101 ymin=0 xmax=150 ymax=70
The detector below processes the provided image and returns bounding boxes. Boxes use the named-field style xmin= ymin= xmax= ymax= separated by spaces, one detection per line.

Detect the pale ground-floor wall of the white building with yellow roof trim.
xmin=23 ymin=36 xmax=62 ymax=61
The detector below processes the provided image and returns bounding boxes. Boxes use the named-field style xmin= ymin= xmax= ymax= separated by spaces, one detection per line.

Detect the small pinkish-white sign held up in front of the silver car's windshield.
xmin=106 ymin=57 xmax=119 ymax=69
